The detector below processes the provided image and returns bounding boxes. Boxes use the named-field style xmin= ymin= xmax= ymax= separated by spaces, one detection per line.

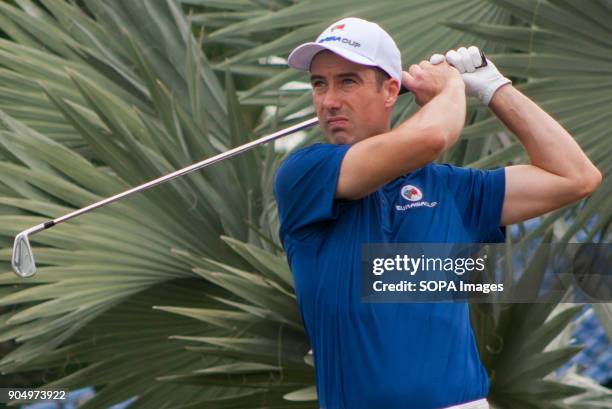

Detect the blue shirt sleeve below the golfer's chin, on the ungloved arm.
xmin=274 ymin=144 xmax=350 ymax=243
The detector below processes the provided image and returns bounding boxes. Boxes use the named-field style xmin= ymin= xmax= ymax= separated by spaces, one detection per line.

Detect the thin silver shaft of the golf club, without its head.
xmin=38 ymin=117 xmax=318 ymax=234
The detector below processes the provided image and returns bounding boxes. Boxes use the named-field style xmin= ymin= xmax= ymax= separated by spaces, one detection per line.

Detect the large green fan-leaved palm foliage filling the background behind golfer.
xmin=0 ymin=0 xmax=612 ymax=409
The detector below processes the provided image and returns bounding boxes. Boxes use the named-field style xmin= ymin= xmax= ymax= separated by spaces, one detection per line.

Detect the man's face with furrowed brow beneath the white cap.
xmin=310 ymin=51 xmax=398 ymax=144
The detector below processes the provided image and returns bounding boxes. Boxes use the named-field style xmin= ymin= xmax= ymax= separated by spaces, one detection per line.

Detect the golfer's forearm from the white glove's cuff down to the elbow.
xmin=489 ymin=85 xmax=598 ymax=188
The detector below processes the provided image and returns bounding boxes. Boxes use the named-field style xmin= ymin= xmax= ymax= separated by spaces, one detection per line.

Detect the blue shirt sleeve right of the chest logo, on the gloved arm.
xmin=440 ymin=165 xmax=506 ymax=243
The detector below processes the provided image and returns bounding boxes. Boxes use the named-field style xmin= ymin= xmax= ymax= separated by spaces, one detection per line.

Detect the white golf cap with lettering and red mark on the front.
xmin=288 ymin=17 xmax=402 ymax=84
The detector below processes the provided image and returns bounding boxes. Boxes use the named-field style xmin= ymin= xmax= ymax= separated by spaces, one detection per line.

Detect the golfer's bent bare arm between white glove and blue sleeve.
xmin=489 ymin=85 xmax=602 ymax=226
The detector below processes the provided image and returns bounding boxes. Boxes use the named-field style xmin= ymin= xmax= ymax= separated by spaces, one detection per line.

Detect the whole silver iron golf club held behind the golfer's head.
xmin=11 ymin=51 xmax=487 ymax=278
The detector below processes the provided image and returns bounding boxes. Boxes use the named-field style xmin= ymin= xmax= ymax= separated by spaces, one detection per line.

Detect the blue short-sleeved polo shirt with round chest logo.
xmin=274 ymin=144 xmax=505 ymax=409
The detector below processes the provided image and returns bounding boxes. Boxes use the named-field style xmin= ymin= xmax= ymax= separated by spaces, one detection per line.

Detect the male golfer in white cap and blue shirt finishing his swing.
xmin=275 ymin=18 xmax=601 ymax=409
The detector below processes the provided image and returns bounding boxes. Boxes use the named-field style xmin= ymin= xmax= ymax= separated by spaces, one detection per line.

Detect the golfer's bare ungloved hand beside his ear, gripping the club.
xmin=402 ymin=61 xmax=465 ymax=106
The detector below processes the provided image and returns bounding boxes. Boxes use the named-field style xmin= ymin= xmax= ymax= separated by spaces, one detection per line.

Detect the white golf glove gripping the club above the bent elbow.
xmin=429 ymin=46 xmax=511 ymax=105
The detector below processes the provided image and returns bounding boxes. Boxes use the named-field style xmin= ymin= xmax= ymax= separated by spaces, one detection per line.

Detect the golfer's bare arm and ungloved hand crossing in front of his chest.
xmin=336 ymin=62 xmax=466 ymax=200
